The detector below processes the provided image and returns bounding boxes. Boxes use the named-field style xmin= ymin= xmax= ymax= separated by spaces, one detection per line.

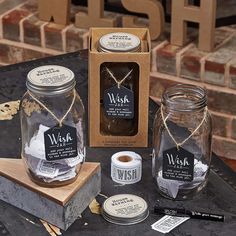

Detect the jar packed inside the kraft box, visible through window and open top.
xmin=98 ymin=32 xmax=141 ymax=136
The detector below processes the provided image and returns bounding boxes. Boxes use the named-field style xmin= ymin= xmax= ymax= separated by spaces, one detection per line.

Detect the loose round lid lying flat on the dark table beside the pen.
xmin=102 ymin=194 xmax=149 ymax=225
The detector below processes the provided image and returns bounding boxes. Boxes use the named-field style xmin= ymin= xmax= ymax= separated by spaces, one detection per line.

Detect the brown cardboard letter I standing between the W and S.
xmin=75 ymin=0 xmax=116 ymax=28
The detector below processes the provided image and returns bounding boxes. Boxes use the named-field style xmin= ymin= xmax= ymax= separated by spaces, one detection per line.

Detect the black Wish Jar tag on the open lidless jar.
xmin=162 ymin=147 xmax=194 ymax=182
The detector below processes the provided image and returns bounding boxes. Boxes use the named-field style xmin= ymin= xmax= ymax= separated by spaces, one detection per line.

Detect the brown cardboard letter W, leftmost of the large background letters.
xmin=38 ymin=0 xmax=71 ymax=25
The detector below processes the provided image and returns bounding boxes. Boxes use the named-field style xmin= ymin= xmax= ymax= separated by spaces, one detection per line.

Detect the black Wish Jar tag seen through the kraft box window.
xmin=104 ymin=86 xmax=134 ymax=119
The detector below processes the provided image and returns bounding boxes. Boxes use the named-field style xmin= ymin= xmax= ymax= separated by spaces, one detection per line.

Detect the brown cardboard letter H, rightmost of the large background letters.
xmin=171 ymin=0 xmax=216 ymax=51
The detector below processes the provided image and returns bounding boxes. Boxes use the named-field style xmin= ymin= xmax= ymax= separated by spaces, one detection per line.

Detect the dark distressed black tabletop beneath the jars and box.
xmin=0 ymin=51 xmax=236 ymax=236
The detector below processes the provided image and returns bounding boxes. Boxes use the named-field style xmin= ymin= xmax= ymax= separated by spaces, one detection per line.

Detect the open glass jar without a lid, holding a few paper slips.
xmin=152 ymin=85 xmax=212 ymax=200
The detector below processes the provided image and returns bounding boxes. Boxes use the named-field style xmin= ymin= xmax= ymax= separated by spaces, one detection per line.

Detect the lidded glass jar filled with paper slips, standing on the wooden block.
xmin=20 ymin=65 xmax=85 ymax=187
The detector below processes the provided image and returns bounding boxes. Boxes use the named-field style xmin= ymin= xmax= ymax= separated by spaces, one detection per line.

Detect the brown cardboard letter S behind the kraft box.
xmin=122 ymin=0 xmax=164 ymax=40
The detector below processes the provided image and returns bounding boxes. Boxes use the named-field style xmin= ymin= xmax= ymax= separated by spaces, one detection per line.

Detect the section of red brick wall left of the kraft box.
xmin=0 ymin=0 xmax=91 ymax=65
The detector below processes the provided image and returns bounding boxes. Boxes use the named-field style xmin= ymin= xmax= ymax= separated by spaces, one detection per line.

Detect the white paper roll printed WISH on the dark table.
xmin=111 ymin=151 xmax=142 ymax=184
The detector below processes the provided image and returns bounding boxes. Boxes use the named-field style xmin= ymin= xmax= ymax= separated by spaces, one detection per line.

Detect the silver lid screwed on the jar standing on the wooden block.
xmin=26 ymin=65 xmax=76 ymax=96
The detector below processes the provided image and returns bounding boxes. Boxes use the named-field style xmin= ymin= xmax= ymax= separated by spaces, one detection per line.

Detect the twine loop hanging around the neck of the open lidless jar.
xmin=161 ymin=105 xmax=208 ymax=150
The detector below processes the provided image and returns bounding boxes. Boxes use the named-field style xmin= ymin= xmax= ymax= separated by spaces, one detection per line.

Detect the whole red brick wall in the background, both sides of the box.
xmin=0 ymin=0 xmax=236 ymax=160
